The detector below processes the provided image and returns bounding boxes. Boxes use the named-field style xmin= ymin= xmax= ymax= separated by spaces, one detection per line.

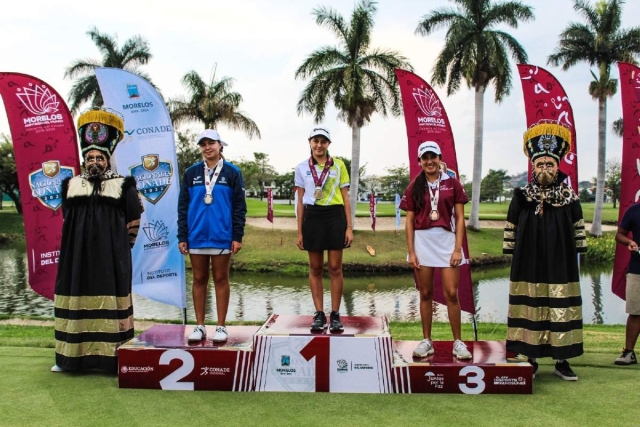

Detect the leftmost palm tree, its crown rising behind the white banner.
xmin=64 ymin=27 xmax=157 ymax=114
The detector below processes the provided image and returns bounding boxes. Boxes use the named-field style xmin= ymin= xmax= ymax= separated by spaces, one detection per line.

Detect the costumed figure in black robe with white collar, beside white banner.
xmin=51 ymin=109 xmax=142 ymax=373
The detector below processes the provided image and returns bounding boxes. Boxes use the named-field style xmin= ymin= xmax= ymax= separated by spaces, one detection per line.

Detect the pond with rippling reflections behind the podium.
xmin=0 ymin=247 xmax=627 ymax=324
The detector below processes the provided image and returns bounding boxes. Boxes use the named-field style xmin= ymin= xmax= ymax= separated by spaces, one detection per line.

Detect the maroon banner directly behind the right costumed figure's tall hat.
xmin=518 ymin=64 xmax=579 ymax=190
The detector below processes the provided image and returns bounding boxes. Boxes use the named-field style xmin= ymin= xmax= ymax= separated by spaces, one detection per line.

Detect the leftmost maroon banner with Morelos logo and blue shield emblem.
xmin=0 ymin=73 xmax=80 ymax=299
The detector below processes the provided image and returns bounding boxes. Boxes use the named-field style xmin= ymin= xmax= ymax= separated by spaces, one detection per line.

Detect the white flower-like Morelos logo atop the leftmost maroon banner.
xmin=16 ymin=83 xmax=63 ymax=128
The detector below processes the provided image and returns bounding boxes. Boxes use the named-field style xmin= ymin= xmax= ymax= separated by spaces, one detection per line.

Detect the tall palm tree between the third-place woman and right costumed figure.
xmin=416 ymin=0 xmax=534 ymax=230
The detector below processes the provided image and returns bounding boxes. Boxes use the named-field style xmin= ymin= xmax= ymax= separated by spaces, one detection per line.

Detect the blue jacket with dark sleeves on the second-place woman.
xmin=178 ymin=160 xmax=247 ymax=249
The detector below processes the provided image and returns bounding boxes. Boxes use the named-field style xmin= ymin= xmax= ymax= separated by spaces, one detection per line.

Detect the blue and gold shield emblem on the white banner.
xmin=129 ymin=154 xmax=173 ymax=205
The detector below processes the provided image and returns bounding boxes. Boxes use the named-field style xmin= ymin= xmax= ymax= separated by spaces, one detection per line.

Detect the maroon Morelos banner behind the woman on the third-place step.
xmin=396 ymin=68 xmax=476 ymax=314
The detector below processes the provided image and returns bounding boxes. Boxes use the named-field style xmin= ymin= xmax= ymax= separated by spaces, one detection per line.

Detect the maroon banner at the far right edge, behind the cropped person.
xmin=611 ymin=62 xmax=640 ymax=299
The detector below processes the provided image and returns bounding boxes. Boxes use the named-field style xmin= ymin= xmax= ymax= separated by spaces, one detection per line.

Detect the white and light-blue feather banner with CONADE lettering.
xmin=95 ymin=68 xmax=186 ymax=308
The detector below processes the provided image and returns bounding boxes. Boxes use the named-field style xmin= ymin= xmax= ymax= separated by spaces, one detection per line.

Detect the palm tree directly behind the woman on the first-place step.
xmin=295 ymin=0 xmax=413 ymax=226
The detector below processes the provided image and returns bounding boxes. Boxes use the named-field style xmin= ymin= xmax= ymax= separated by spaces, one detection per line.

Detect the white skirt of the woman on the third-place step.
xmin=407 ymin=227 xmax=469 ymax=268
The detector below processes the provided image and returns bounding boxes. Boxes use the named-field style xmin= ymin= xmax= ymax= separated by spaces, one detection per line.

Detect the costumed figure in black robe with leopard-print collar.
xmin=503 ymin=121 xmax=587 ymax=381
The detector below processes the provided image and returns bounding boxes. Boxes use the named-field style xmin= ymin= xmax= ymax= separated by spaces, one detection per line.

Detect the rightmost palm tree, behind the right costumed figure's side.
xmin=547 ymin=0 xmax=640 ymax=236
